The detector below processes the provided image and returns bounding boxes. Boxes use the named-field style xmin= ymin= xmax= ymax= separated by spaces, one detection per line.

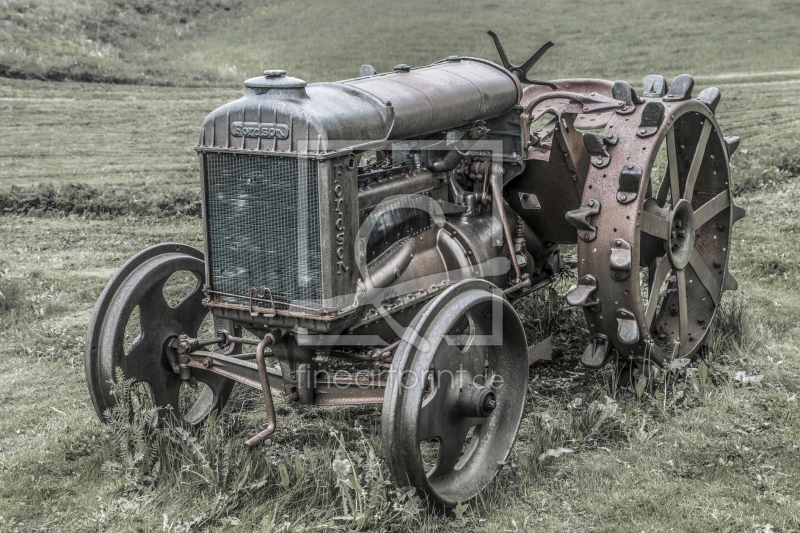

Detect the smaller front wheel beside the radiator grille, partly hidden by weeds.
xmin=85 ymin=243 xmax=239 ymax=425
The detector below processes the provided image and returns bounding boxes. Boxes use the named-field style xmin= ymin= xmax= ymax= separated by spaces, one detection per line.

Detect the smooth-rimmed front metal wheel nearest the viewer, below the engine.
xmin=382 ymin=280 xmax=528 ymax=506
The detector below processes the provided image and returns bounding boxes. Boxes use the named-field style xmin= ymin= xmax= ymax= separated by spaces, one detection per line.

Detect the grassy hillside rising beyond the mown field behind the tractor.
xmin=0 ymin=0 xmax=800 ymax=86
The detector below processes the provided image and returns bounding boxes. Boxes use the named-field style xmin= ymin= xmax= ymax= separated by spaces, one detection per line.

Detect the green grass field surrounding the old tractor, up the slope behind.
xmin=0 ymin=0 xmax=800 ymax=533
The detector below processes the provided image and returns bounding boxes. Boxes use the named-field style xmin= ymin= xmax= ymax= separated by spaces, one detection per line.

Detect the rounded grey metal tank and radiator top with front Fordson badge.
xmin=197 ymin=56 xmax=522 ymax=156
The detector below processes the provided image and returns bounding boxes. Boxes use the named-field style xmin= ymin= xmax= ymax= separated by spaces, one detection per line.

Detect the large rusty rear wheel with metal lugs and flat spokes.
xmin=578 ymin=82 xmax=744 ymax=373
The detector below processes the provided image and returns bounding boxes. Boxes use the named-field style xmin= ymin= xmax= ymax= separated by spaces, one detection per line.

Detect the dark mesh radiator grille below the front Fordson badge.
xmin=205 ymin=153 xmax=322 ymax=311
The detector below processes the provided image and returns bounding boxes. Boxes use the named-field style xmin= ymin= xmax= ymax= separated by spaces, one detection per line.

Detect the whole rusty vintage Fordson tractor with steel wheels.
xmin=86 ymin=32 xmax=744 ymax=506
